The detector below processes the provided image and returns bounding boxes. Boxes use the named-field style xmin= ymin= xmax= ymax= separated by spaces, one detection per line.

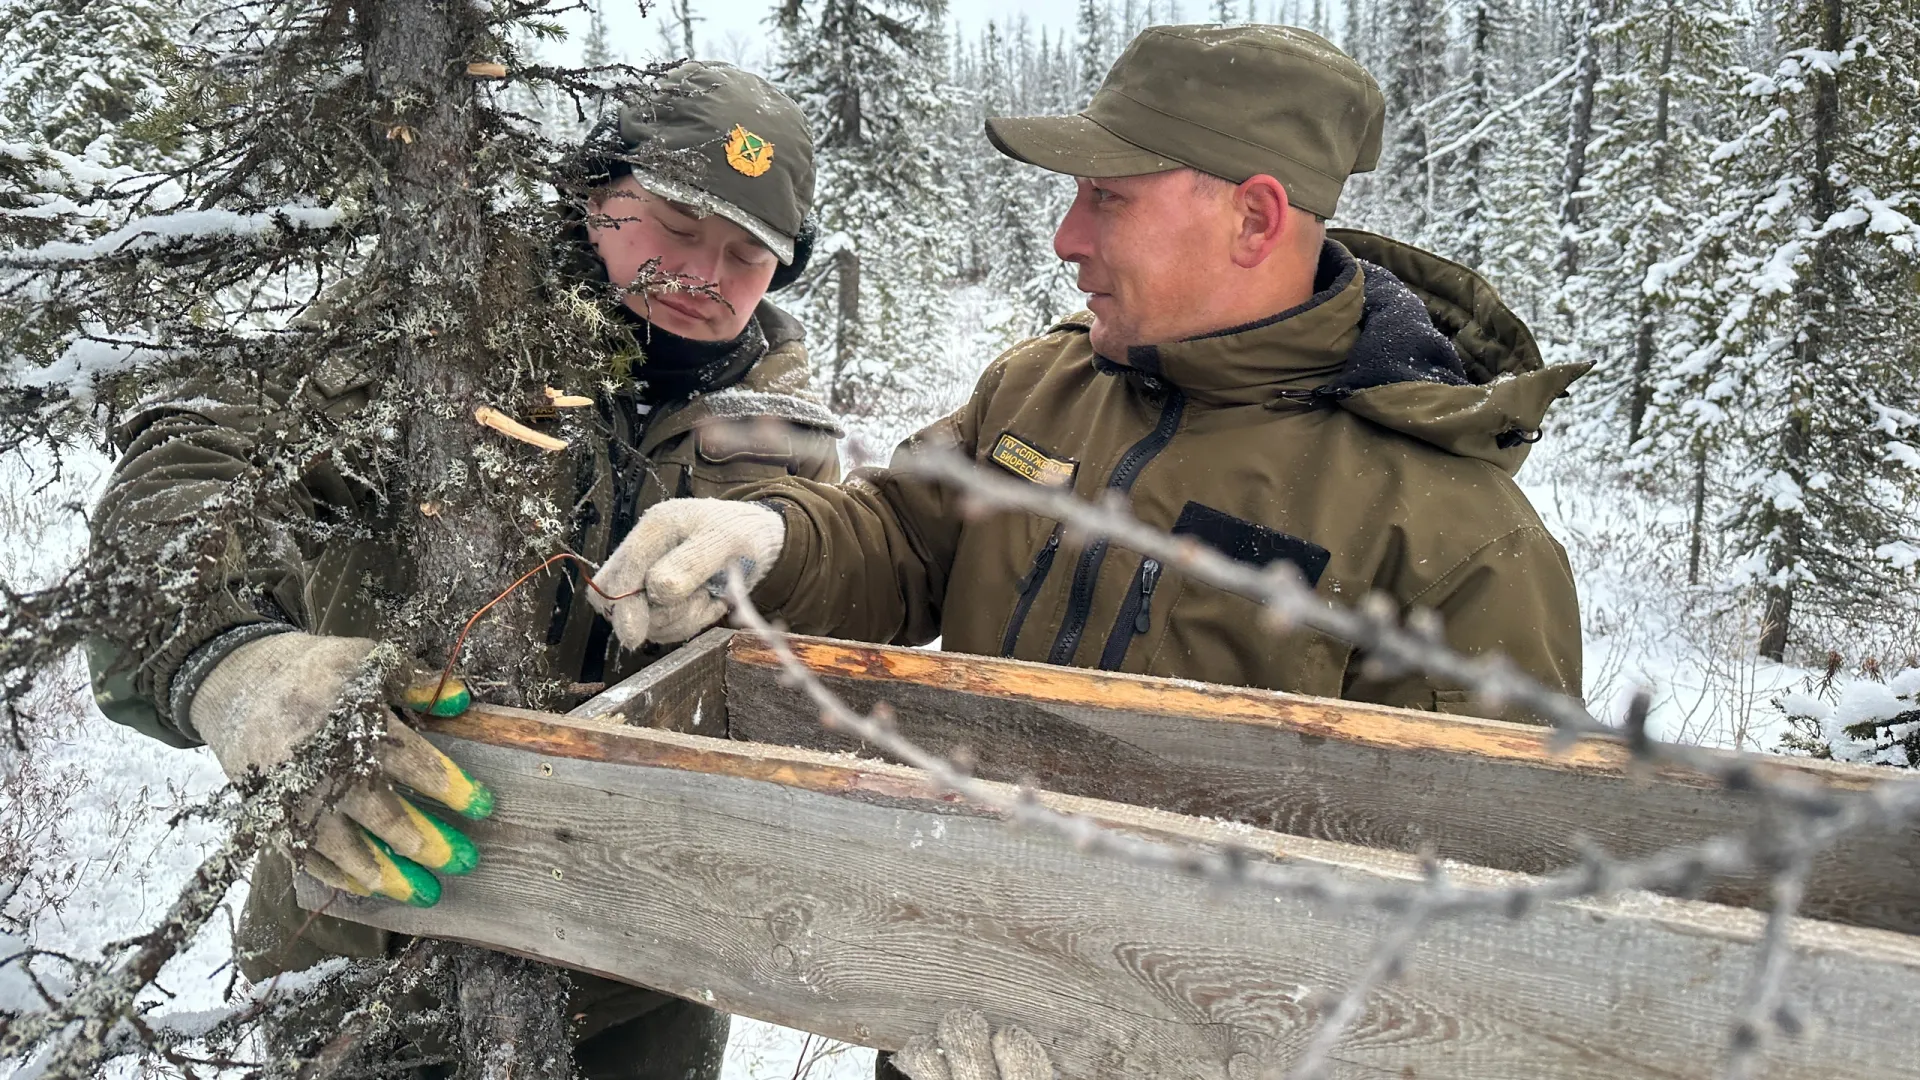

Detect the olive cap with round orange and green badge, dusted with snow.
xmin=620 ymin=60 xmax=814 ymax=263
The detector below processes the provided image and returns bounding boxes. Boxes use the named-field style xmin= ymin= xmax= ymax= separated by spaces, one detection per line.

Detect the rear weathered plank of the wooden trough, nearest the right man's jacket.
xmin=726 ymin=634 xmax=1920 ymax=932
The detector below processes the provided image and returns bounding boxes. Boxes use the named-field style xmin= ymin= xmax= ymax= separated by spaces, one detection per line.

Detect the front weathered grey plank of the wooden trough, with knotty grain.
xmin=303 ymin=707 xmax=1920 ymax=1080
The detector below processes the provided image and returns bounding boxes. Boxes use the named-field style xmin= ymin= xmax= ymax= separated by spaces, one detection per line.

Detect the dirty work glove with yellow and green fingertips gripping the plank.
xmin=186 ymin=632 xmax=493 ymax=907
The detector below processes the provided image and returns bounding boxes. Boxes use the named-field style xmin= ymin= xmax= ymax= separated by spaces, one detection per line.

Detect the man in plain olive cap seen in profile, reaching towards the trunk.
xmin=591 ymin=25 xmax=1588 ymax=1060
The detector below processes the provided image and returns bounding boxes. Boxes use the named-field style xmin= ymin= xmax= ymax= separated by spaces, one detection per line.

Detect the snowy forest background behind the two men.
xmin=0 ymin=0 xmax=1920 ymax=1076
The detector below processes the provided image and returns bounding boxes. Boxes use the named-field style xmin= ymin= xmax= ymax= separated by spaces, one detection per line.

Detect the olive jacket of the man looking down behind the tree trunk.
xmin=88 ymin=294 xmax=839 ymax=746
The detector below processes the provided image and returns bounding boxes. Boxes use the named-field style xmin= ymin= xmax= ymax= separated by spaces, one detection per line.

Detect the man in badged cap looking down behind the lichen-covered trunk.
xmin=88 ymin=61 xmax=839 ymax=1080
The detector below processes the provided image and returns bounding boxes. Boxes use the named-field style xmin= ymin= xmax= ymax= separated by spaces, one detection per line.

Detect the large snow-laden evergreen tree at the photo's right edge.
xmin=1665 ymin=0 xmax=1920 ymax=659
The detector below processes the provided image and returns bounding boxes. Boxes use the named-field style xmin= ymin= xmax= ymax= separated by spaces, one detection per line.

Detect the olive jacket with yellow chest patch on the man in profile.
xmin=732 ymin=231 xmax=1586 ymax=715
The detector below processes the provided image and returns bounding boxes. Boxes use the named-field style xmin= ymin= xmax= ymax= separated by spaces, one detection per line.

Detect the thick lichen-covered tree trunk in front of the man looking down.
xmin=357 ymin=0 xmax=572 ymax=1080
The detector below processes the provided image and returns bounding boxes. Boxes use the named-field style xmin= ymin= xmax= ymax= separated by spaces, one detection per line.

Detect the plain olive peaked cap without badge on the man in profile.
xmin=987 ymin=25 xmax=1386 ymax=217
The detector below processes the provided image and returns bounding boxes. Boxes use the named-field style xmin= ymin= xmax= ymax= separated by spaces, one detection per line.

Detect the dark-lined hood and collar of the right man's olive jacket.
xmin=1073 ymin=229 xmax=1592 ymax=473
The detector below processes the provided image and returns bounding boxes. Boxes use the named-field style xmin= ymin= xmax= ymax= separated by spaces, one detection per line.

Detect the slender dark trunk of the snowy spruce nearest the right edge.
xmin=1761 ymin=0 xmax=1845 ymax=661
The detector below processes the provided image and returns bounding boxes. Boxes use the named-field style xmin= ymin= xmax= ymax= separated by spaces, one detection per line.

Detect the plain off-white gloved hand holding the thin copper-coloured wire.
xmin=588 ymin=500 xmax=787 ymax=650
